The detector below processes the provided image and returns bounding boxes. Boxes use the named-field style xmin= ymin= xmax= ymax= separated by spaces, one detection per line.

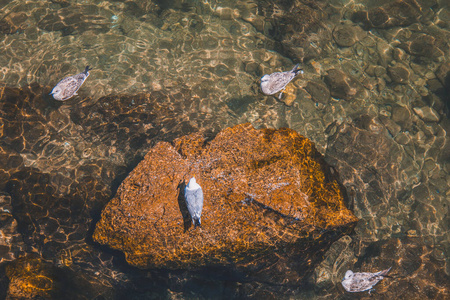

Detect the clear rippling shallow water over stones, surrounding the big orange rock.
xmin=0 ymin=0 xmax=450 ymax=299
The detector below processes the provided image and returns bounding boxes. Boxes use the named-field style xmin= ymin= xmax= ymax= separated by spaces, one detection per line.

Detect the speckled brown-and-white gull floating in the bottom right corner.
xmin=342 ymin=268 xmax=391 ymax=292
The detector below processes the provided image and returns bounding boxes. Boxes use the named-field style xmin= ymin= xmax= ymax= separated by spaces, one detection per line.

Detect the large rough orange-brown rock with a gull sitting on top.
xmin=93 ymin=124 xmax=357 ymax=284
